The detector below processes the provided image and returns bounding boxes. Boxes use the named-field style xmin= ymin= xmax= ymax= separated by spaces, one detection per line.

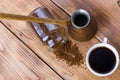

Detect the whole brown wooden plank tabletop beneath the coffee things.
xmin=0 ymin=0 xmax=120 ymax=80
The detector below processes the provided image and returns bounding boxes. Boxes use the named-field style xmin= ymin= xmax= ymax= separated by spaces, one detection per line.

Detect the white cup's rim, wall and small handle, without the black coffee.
xmin=86 ymin=37 xmax=119 ymax=76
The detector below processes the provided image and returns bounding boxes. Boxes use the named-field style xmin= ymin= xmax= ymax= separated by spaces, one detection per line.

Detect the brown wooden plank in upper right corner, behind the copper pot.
xmin=52 ymin=0 xmax=120 ymax=52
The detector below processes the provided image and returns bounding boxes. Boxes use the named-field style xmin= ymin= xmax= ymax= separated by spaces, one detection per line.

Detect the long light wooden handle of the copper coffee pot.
xmin=0 ymin=13 xmax=70 ymax=26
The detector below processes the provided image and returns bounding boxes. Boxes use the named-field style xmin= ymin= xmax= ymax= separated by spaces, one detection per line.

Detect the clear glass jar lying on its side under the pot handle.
xmin=30 ymin=7 xmax=67 ymax=47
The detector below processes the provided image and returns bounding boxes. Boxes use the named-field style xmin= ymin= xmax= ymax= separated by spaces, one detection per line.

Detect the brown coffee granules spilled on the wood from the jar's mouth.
xmin=53 ymin=40 xmax=83 ymax=66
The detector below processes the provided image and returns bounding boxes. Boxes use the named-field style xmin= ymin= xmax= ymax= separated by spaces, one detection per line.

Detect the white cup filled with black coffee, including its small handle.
xmin=86 ymin=37 xmax=119 ymax=76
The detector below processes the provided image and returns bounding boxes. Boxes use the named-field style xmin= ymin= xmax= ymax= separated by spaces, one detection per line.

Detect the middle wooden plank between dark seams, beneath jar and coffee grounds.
xmin=0 ymin=0 xmax=116 ymax=80
